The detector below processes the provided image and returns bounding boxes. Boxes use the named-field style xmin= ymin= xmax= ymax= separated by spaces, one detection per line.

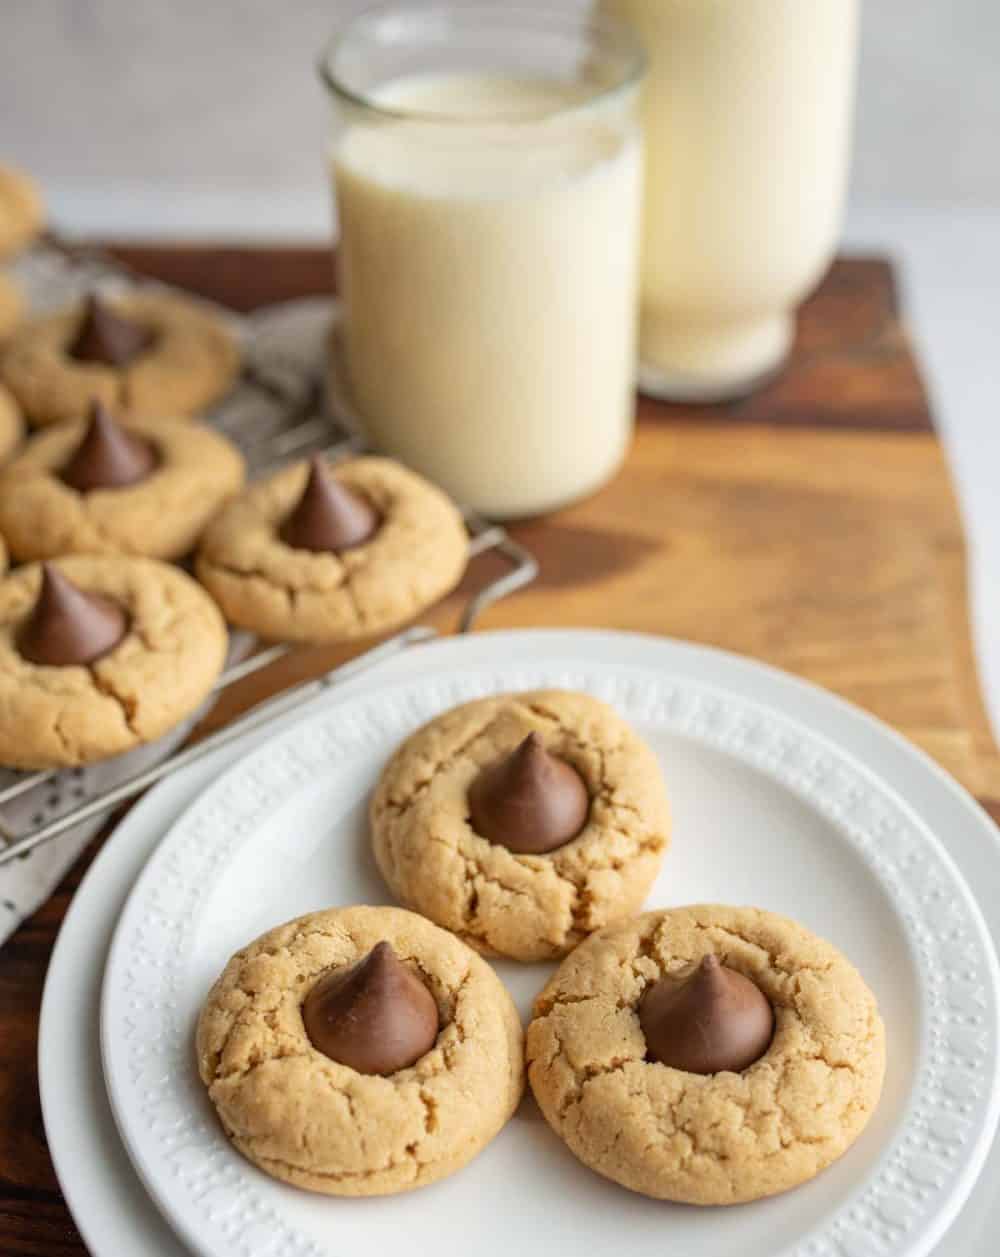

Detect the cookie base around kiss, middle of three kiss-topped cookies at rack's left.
xmin=0 ymin=419 xmax=244 ymax=561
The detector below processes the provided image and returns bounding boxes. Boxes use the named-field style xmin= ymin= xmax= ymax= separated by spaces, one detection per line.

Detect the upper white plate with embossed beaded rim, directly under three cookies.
xmin=95 ymin=634 xmax=1000 ymax=1257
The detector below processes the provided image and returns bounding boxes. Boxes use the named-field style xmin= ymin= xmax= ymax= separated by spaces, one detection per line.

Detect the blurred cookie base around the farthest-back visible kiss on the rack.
xmin=0 ymin=292 xmax=240 ymax=427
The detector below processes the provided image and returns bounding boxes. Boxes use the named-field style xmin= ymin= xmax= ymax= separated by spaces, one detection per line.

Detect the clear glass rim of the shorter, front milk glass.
xmin=318 ymin=0 xmax=646 ymax=127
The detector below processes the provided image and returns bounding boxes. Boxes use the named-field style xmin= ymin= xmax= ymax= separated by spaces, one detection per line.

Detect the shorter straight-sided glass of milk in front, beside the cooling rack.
xmin=320 ymin=3 xmax=643 ymax=518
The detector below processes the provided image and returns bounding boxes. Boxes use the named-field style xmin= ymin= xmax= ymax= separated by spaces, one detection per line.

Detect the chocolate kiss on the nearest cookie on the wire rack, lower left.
xmin=18 ymin=563 xmax=128 ymax=667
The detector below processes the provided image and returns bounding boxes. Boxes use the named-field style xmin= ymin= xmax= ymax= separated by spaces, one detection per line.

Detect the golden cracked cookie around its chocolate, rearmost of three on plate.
xmin=371 ymin=690 xmax=670 ymax=960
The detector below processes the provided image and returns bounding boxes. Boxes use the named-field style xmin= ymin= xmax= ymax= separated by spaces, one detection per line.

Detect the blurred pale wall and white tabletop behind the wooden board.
xmin=0 ymin=0 xmax=1000 ymax=728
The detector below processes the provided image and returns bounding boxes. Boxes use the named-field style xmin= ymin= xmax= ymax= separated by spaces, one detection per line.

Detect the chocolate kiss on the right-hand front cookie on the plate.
xmin=639 ymin=955 xmax=774 ymax=1073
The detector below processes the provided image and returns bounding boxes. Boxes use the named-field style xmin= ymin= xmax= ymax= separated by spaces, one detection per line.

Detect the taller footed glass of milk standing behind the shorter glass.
xmin=598 ymin=0 xmax=858 ymax=401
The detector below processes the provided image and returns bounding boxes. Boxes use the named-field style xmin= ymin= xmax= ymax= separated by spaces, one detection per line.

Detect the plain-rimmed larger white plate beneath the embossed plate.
xmin=39 ymin=631 xmax=1000 ymax=1257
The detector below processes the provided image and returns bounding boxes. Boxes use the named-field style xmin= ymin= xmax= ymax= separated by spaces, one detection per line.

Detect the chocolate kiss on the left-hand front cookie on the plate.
xmin=302 ymin=943 xmax=440 ymax=1075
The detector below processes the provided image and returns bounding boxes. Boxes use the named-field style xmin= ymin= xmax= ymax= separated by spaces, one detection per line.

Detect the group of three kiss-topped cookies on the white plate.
xmin=196 ymin=690 xmax=884 ymax=1205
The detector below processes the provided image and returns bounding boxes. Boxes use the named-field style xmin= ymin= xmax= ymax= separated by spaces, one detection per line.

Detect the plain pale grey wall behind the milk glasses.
xmin=0 ymin=0 xmax=1000 ymax=206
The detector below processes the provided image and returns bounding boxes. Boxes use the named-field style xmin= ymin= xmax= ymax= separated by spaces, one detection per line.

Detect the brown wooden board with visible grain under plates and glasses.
xmin=0 ymin=246 xmax=1000 ymax=1257
